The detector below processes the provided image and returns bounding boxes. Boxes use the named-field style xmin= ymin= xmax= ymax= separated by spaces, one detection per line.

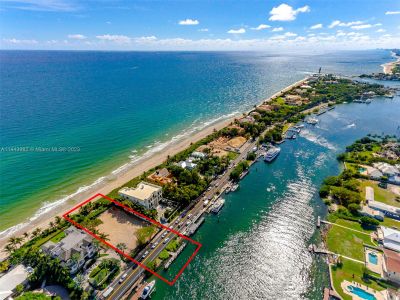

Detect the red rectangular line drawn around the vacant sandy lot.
xmin=62 ymin=193 xmax=202 ymax=286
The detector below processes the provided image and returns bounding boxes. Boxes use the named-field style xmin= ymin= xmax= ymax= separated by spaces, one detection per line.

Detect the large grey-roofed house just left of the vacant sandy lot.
xmin=42 ymin=226 xmax=96 ymax=274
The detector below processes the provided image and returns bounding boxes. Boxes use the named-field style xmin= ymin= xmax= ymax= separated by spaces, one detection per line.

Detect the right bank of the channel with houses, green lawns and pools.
xmin=318 ymin=135 xmax=400 ymax=300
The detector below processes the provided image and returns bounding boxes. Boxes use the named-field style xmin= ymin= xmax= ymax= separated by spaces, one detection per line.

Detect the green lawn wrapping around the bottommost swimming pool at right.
xmin=330 ymin=259 xmax=384 ymax=300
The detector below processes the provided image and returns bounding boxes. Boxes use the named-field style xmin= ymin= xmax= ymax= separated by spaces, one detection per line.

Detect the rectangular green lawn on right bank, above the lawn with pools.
xmin=326 ymin=225 xmax=375 ymax=261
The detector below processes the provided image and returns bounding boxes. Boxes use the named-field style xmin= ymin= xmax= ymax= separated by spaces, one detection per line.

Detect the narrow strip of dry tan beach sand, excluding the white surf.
xmin=0 ymin=78 xmax=307 ymax=255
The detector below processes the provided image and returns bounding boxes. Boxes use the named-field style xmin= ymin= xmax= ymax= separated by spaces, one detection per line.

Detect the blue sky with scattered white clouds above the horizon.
xmin=0 ymin=0 xmax=400 ymax=51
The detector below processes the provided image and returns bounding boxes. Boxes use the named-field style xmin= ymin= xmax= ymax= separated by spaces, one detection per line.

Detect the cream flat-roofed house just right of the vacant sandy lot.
xmin=118 ymin=181 xmax=162 ymax=209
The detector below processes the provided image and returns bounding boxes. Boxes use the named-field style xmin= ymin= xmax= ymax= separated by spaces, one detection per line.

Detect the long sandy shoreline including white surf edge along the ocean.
xmin=0 ymin=76 xmax=309 ymax=253
